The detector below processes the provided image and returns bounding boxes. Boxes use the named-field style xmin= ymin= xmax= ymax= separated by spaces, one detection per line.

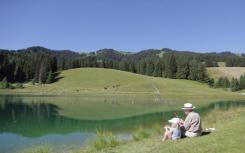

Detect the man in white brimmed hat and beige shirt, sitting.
xmin=180 ymin=103 xmax=202 ymax=137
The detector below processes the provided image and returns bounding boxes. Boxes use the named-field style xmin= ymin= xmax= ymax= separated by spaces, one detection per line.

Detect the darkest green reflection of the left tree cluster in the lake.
xmin=0 ymin=96 xmax=59 ymax=136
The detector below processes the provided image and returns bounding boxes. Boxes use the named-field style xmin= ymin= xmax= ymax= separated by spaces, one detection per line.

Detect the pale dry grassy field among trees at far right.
xmin=208 ymin=67 xmax=245 ymax=79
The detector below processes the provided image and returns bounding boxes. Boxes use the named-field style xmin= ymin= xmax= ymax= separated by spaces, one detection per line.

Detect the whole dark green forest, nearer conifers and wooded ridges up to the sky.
xmin=0 ymin=46 xmax=245 ymax=88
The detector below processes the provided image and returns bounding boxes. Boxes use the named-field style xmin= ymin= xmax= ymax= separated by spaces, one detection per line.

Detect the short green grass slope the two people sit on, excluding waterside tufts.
xmin=81 ymin=108 xmax=245 ymax=153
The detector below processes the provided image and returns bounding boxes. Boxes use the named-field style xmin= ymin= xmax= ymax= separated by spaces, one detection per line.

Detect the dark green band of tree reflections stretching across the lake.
xmin=0 ymin=96 xmax=245 ymax=137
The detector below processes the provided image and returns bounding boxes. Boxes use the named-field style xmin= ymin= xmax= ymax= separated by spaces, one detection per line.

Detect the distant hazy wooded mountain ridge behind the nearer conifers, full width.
xmin=0 ymin=46 xmax=245 ymax=66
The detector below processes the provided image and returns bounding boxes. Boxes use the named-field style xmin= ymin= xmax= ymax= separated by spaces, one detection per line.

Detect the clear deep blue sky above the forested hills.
xmin=0 ymin=0 xmax=245 ymax=52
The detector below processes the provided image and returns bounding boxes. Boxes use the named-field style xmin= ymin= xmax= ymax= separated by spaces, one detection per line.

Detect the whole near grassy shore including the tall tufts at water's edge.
xmin=24 ymin=108 xmax=245 ymax=153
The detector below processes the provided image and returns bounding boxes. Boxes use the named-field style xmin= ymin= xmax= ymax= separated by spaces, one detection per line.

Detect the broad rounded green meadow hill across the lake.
xmin=3 ymin=68 xmax=243 ymax=101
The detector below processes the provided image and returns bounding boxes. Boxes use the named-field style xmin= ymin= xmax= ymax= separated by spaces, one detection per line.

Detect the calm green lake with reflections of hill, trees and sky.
xmin=0 ymin=95 xmax=245 ymax=153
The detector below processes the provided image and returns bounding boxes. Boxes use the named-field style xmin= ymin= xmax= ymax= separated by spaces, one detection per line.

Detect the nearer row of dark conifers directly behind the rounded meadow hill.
xmin=0 ymin=48 xmax=207 ymax=84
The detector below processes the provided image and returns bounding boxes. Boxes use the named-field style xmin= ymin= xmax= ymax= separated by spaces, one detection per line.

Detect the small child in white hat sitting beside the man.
xmin=162 ymin=118 xmax=181 ymax=141
